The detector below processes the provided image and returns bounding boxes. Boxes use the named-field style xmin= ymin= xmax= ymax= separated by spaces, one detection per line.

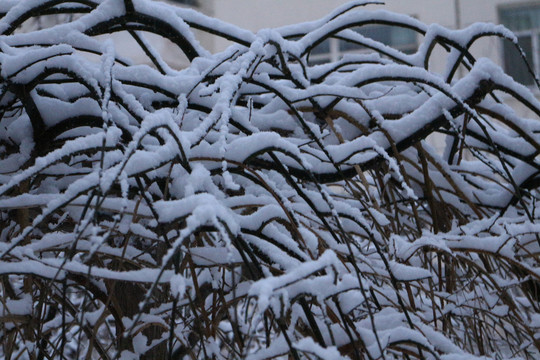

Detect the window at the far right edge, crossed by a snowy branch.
xmin=499 ymin=5 xmax=540 ymax=85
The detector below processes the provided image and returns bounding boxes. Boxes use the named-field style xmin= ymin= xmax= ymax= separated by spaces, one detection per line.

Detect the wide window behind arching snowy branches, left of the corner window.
xmin=309 ymin=25 xmax=417 ymax=64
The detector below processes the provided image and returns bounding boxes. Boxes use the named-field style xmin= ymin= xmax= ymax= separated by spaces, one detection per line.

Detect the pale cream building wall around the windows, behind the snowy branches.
xmin=205 ymin=0 xmax=524 ymax=68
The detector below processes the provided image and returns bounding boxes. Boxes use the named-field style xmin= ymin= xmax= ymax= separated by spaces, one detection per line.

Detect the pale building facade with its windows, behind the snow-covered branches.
xmin=161 ymin=0 xmax=540 ymax=89
